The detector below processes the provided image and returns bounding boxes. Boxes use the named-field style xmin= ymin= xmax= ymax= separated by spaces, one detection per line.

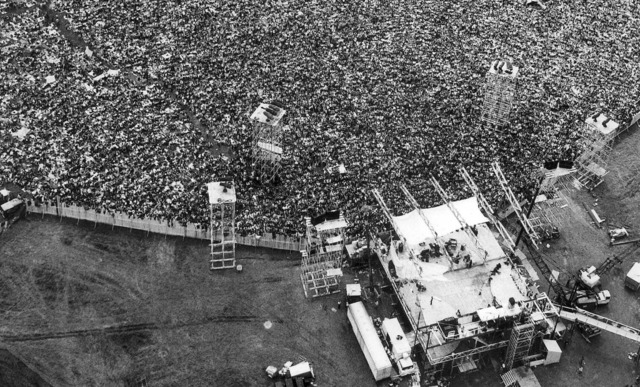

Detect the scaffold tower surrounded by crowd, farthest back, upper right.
xmin=480 ymin=61 xmax=518 ymax=127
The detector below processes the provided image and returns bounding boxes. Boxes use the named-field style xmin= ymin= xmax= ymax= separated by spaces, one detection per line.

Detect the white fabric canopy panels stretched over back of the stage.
xmin=393 ymin=196 xmax=489 ymax=245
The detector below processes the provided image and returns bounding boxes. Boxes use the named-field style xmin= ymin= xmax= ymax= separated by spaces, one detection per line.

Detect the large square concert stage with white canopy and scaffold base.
xmin=373 ymin=181 xmax=558 ymax=377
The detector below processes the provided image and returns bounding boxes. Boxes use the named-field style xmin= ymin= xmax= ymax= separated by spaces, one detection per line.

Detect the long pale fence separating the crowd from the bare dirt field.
xmin=27 ymin=202 xmax=304 ymax=251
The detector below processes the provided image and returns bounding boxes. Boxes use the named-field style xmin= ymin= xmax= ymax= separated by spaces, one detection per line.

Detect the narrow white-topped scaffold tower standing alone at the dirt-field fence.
xmin=207 ymin=182 xmax=236 ymax=270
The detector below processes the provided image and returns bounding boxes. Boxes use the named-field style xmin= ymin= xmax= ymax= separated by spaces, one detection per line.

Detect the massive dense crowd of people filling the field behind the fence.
xmin=0 ymin=0 xmax=640 ymax=235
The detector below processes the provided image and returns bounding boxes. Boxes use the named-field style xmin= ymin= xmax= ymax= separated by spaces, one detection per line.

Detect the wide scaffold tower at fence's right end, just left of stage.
xmin=300 ymin=212 xmax=347 ymax=298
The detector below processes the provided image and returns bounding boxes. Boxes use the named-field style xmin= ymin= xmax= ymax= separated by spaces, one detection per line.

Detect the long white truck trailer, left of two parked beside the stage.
xmin=347 ymin=302 xmax=393 ymax=381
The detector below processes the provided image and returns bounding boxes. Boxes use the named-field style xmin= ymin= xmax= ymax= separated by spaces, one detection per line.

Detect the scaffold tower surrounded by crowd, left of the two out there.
xmin=251 ymin=101 xmax=286 ymax=184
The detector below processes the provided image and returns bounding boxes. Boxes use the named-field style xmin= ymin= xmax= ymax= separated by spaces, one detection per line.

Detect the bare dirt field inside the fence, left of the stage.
xmin=0 ymin=217 xmax=376 ymax=387
